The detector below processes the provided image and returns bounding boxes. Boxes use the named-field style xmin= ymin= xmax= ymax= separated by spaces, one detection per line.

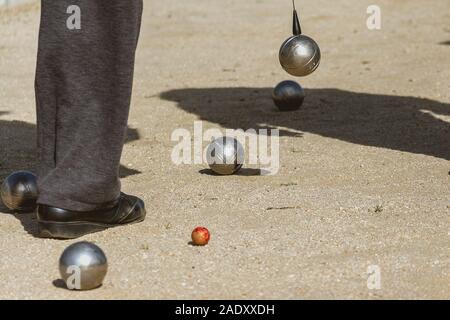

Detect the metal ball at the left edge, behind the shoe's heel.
xmin=0 ymin=171 xmax=38 ymax=212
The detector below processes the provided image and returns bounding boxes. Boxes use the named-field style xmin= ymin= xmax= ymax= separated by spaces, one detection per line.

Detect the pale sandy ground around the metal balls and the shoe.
xmin=0 ymin=0 xmax=450 ymax=299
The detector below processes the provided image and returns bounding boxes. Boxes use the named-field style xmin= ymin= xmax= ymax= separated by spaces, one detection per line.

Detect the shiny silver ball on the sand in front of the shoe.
xmin=59 ymin=242 xmax=108 ymax=290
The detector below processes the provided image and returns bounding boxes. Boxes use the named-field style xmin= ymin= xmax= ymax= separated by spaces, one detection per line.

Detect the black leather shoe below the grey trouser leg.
xmin=37 ymin=193 xmax=146 ymax=239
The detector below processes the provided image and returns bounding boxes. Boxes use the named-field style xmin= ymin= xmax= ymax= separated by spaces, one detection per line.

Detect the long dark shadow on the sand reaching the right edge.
xmin=160 ymin=88 xmax=450 ymax=160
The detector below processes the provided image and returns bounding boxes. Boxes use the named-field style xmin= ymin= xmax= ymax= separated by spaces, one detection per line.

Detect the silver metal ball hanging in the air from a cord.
xmin=279 ymin=35 xmax=321 ymax=77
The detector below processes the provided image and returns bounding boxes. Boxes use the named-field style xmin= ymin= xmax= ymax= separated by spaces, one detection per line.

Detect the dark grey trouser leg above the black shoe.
xmin=35 ymin=0 xmax=143 ymax=211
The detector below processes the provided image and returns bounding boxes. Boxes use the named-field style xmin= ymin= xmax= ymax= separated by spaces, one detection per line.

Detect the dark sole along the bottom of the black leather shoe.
xmin=38 ymin=216 xmax=145 ymax=240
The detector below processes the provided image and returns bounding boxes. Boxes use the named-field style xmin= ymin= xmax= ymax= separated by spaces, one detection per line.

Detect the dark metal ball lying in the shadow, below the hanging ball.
xmin=272 ymin=80 xmax=305 ymax=111
